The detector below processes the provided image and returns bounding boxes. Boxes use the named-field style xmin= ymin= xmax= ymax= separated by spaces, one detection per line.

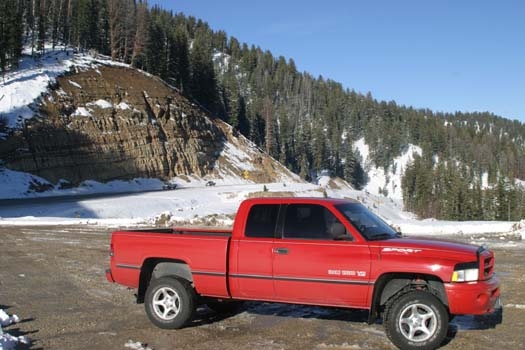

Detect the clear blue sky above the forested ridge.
xmin=149 ymin=0 xmax=525 ymax=122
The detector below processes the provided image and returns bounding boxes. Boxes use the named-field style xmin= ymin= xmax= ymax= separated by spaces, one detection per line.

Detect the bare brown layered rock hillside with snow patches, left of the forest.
xmin=0 ymin=51 xmax=297 ymax=197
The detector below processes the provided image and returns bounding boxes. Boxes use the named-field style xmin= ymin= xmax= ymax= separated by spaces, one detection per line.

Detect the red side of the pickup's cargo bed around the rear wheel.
xmin=111 ymin=228 xmax=231 ymax=297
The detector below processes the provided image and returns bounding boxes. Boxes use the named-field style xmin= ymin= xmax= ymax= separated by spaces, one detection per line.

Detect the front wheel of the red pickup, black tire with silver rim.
xmin=383 ymin=291 xmax=448 ymax=350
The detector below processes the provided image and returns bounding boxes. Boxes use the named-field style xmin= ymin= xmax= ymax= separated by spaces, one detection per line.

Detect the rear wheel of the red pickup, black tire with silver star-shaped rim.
xmin=144 ymin=277 xmax=195 ymax=329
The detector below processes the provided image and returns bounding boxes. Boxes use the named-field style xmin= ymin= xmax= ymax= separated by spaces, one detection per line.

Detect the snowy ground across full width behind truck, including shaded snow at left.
xmin=0 ymin=169 xmax=525 ymax=247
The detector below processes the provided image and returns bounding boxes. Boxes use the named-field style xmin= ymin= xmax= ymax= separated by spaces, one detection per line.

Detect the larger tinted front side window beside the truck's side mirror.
xmin=283 ymin=204 xmax=344 ymax=240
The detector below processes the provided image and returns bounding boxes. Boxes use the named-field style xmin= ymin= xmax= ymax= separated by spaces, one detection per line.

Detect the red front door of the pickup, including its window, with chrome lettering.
xmin=272 ymin=204 xmax=370 ymax=307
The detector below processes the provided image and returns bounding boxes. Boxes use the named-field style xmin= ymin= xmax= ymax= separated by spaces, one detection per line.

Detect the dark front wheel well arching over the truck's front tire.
xmin=368 ymin=273 xmax=448 ymax=323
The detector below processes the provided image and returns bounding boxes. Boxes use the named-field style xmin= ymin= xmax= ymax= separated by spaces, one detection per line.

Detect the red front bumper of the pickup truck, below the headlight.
xmin=445 ymin=276 xmax=500 ymax=315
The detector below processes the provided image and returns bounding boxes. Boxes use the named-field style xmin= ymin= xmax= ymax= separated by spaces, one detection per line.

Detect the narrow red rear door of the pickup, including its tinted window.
xmin=229 ymin=204 xmax=280 ymax=300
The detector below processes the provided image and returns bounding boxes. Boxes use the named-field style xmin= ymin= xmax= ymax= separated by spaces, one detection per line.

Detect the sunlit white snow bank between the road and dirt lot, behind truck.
xmin=0 ymin=177 xmax=525 ymax=243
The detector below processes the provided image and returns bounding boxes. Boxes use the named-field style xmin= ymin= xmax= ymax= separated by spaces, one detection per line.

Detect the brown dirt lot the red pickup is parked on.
xmin=0 ymin=226 xmax=525 ymax=350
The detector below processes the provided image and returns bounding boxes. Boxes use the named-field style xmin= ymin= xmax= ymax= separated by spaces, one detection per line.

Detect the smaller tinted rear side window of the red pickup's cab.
xmin=245 ymin=204 xmax=279 ymax=238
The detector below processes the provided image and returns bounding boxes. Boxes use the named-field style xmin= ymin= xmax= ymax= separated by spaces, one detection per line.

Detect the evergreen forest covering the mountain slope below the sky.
xmin=0 ymin=0 xmax=525 ymax=220
